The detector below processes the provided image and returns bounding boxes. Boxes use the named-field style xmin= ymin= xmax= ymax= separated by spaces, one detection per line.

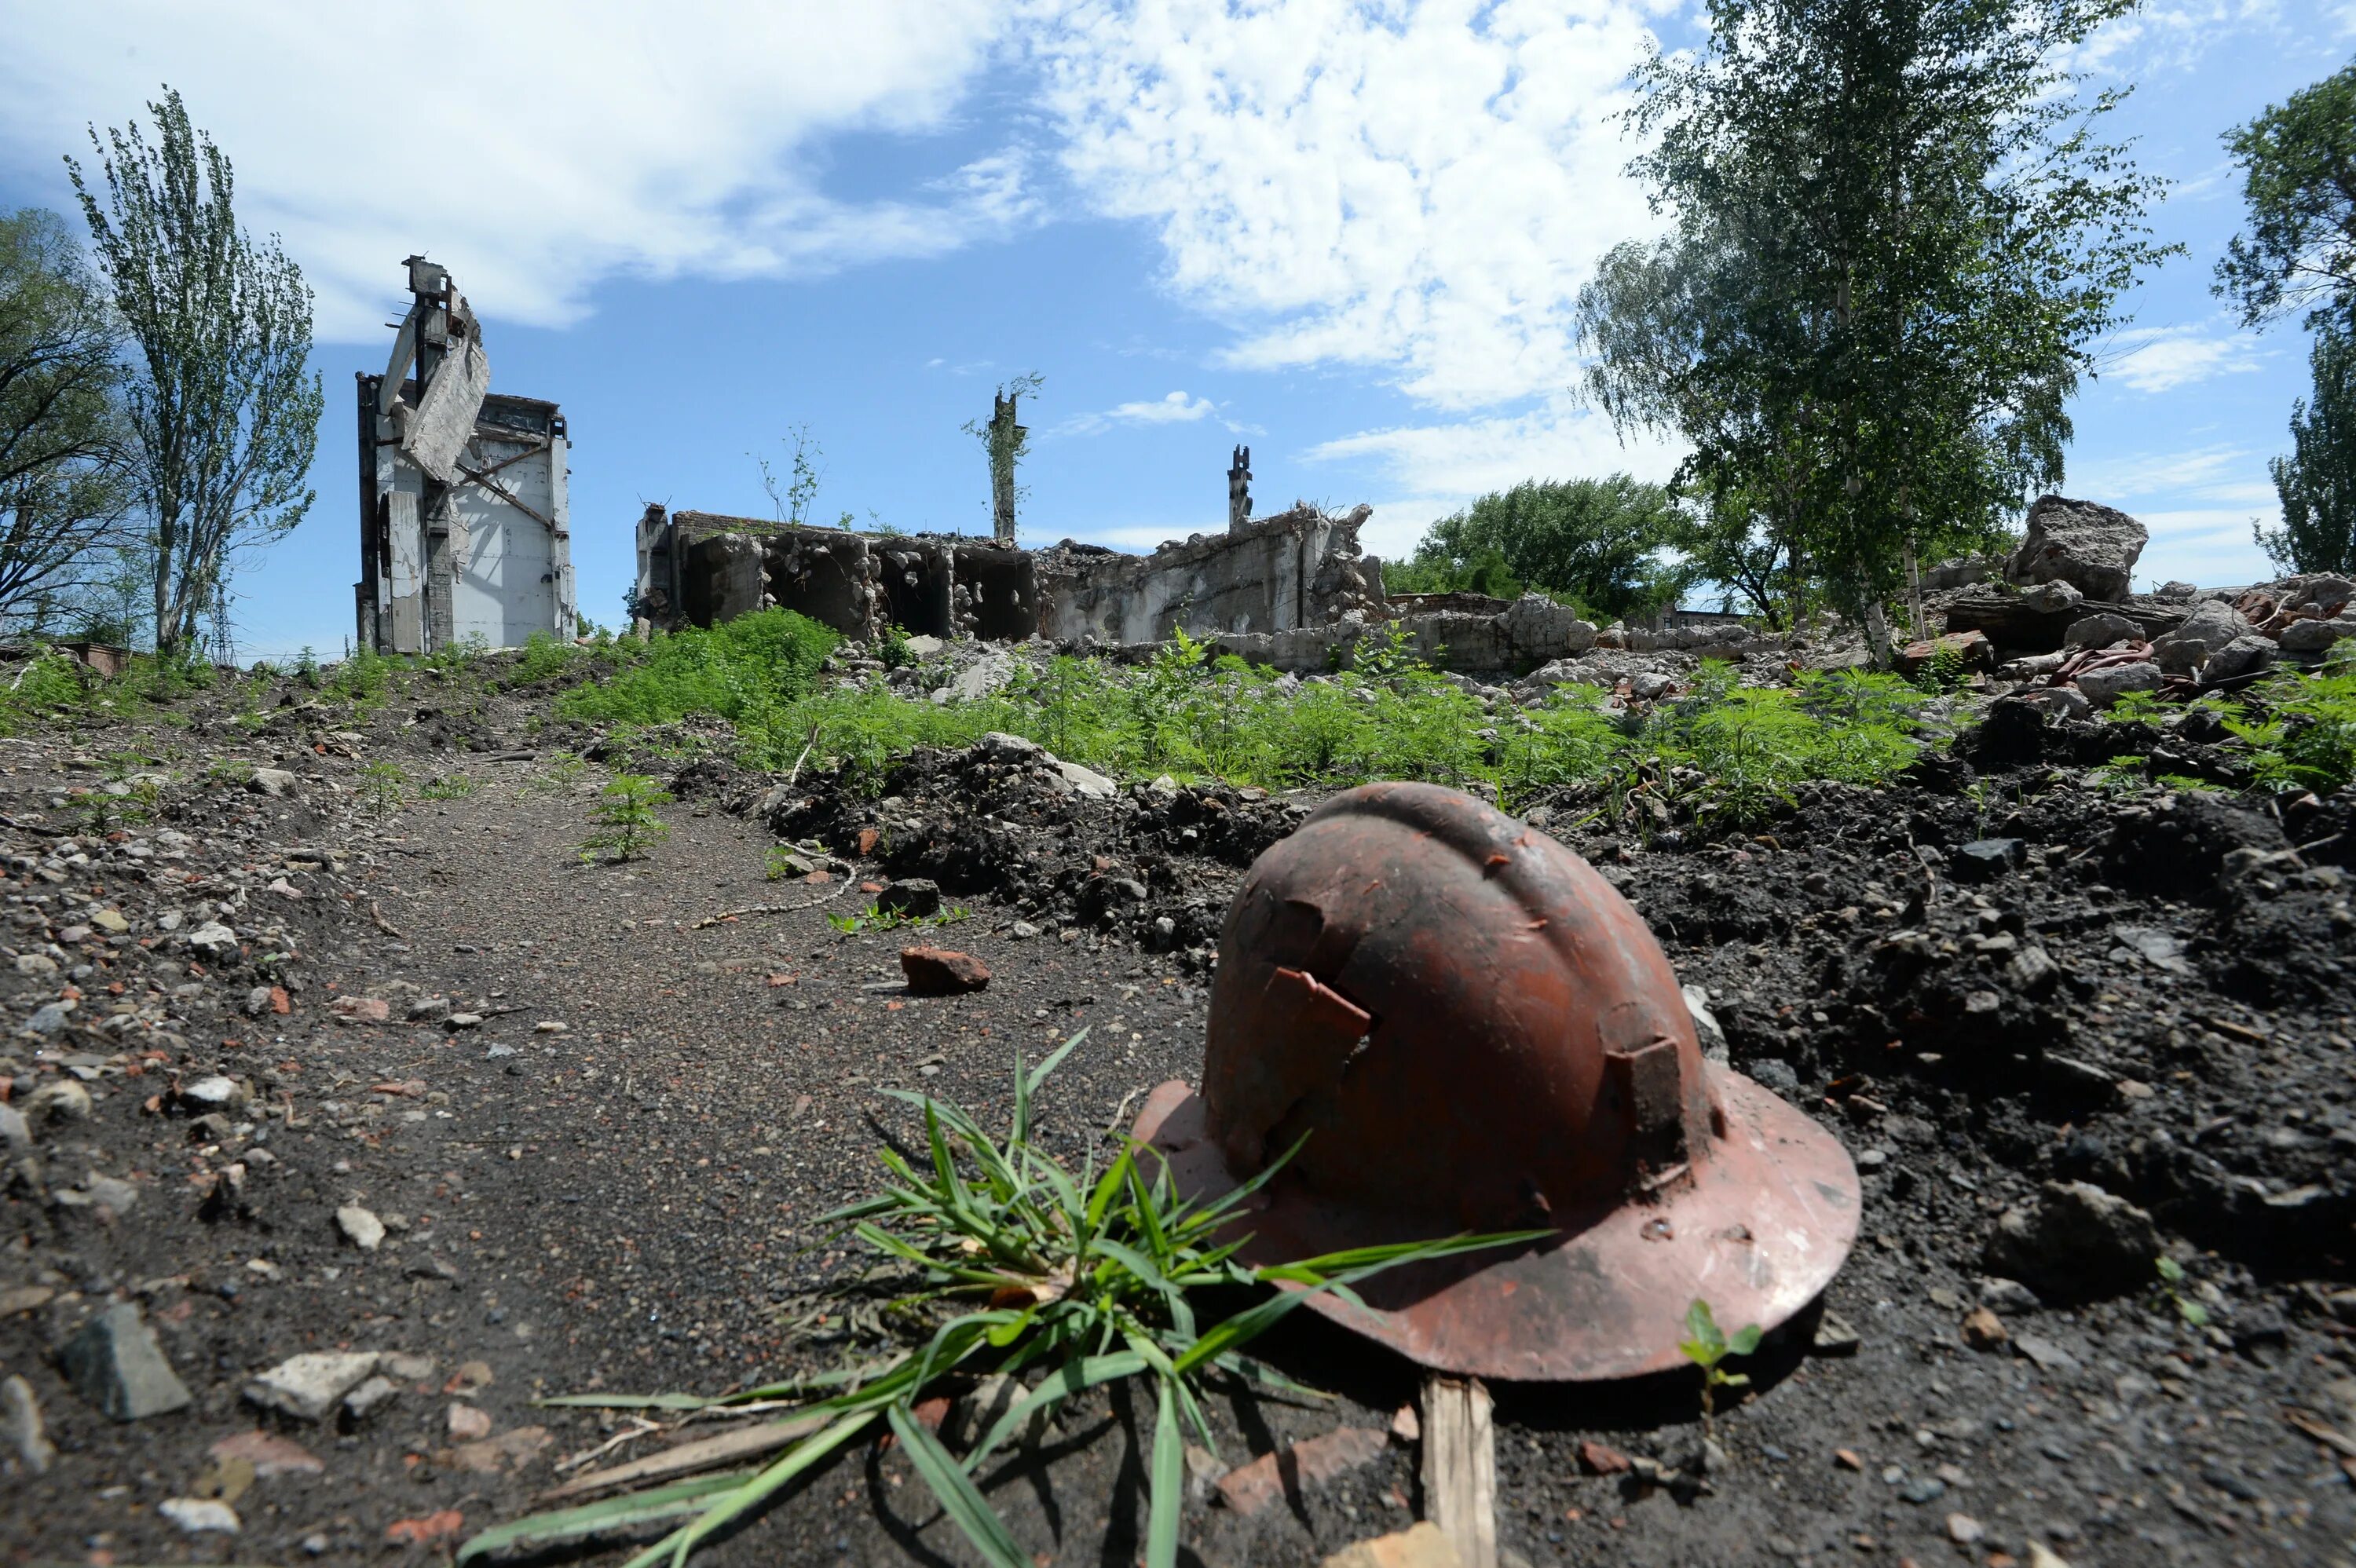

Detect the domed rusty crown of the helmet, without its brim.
xmin=1204 ymin=784 xmax=1713 ymax=1238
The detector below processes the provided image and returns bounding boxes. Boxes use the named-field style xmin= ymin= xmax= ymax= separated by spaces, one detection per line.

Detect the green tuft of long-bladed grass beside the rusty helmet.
xmin=457 ymin=1029 xmax=1546 ymax=1568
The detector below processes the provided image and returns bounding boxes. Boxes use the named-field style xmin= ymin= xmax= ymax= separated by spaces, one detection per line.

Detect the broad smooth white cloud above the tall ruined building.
xmin=0 ymin=0 xmax=1034 ymax=338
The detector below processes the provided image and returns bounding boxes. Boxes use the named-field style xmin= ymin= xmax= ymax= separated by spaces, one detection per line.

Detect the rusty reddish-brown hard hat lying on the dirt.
xmin=1136 ymin=784 xmax=1859 ymax=1382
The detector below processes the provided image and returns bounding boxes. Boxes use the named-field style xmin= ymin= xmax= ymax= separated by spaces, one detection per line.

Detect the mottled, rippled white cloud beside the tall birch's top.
xmin=1041 ymin=0 xmax=1652 ymax=410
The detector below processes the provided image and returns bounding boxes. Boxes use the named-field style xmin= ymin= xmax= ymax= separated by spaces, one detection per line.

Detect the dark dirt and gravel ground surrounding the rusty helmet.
xmin=0 ymin=659 xmax=2356 ymax=1568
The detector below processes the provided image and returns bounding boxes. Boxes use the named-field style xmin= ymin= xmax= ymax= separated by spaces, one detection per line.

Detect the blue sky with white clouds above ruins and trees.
xmin=0 ymin=0 xmax=2356 ymax=657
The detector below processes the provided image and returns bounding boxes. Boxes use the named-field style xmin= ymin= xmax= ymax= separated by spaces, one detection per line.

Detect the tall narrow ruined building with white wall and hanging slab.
xmin=353 ymin=257 xmax=575 ymax=655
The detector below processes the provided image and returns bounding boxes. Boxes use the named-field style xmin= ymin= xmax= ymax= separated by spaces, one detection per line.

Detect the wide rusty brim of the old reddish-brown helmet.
xmin=1136 ymin=1064 xmax=1859 ymax=1382
